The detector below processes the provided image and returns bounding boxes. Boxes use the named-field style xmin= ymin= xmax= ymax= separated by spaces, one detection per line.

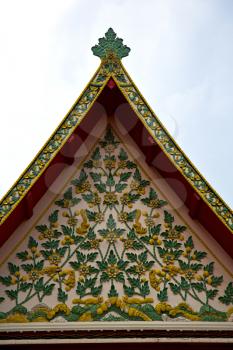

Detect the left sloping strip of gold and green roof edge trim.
xmin=0 ymin=65 xmax=108 ymax=225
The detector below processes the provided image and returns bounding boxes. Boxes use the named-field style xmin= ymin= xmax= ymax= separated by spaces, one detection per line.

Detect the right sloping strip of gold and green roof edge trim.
xmin=111 ymin=63 xmax=233 ymax=233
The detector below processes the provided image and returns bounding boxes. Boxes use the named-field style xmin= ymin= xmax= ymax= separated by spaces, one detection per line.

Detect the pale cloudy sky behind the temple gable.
xmin=0 ymin=0 xmax=233 ymax=207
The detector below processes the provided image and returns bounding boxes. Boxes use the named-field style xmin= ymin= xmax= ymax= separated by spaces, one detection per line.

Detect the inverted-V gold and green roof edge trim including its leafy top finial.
xmin=0 ymin=28 xmax=233 ymax=233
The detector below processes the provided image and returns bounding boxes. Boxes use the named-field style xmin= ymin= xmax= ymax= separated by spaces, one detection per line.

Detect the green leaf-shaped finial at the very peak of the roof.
xmin=91 ymin=28 xmax=130 ymax=60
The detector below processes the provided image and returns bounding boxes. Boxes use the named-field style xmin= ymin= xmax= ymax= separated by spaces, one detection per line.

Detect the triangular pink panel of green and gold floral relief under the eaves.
xmin=0 ymin=129 xmax=233 ymax=322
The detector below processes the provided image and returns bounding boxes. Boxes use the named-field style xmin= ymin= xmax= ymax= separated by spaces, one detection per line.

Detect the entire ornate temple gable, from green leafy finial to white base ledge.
xmin=0 ymin=28 xmax=233 ymax=348
